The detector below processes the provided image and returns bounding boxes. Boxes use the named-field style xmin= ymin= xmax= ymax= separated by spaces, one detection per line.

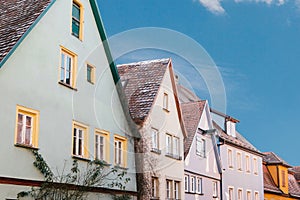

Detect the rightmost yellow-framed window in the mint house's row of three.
xmin=114 ymin=136 xmax=127 ymax=167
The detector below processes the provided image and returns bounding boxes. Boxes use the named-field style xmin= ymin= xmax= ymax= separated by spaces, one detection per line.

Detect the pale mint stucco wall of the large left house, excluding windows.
xmin=0 ymin=0 xmax=136 ymax=198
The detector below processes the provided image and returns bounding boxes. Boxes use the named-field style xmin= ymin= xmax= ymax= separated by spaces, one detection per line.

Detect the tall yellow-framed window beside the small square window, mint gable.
xmin=59 ymin=47 xmax=77 ymax=88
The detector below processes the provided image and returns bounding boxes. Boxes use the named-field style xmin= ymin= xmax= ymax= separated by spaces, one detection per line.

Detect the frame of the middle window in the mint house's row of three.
xmin=94 ymin=129 xmax=110 ymax=163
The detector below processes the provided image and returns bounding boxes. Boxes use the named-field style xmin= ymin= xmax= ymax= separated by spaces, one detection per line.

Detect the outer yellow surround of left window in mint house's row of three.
xmin=71 ymin=120 xmax=89 ymax=159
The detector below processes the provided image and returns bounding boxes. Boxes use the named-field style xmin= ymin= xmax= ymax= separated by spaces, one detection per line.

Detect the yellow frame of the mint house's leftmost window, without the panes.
xmin=15 ymin=105 xmax=40 ymax=148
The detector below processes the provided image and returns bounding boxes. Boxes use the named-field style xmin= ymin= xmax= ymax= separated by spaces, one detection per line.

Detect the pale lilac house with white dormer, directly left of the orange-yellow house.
xmin=211 ymin=109 xmax=264 ymax=200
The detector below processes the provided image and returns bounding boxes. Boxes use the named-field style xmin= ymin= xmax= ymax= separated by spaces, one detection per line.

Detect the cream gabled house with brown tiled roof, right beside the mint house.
xmin=118 ymin=59 xmax=185 ymax=200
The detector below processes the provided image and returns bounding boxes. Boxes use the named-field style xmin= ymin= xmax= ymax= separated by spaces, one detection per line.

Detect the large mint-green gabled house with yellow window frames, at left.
xmin=0 ymin=0 xmax=136 ymax=199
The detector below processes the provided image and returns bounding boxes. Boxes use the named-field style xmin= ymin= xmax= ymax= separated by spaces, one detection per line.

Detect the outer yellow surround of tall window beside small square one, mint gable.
xmin=58 ymin=46 xmax=77 ymax=88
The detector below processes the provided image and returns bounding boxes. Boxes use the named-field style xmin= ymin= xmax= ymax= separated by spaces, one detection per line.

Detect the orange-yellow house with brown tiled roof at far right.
xmin=263 ymin=152 xmax=300 ymax=200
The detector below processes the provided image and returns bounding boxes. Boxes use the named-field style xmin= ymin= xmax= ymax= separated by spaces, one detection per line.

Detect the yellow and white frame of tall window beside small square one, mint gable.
xmin=58 ymin=46 xmax=77 ymax=90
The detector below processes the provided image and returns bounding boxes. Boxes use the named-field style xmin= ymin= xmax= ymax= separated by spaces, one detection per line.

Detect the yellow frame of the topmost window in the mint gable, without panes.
xmin=71 ymin=0 xmax=84 ymax=41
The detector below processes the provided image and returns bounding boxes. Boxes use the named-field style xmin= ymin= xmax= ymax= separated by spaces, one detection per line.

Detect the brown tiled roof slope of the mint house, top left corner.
xmin=0 ymin=0 xmax=51 ymax=62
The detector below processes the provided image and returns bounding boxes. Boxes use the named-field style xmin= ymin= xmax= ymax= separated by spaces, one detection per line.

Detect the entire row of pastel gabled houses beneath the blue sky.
xmin=0 ymin=0 xmax=300 ymax=200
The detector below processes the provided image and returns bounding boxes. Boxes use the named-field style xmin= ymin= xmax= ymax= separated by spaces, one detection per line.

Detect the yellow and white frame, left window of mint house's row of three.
xmin=72 ymin=120 xmax=89 ymax=159
